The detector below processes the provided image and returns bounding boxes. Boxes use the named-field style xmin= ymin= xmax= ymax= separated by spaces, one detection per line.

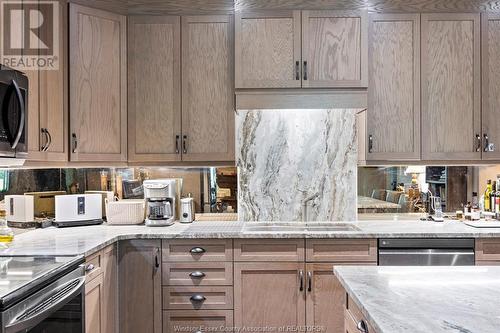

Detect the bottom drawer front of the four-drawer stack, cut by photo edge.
xmin=163 ymin=310 xmax=233 ymax=333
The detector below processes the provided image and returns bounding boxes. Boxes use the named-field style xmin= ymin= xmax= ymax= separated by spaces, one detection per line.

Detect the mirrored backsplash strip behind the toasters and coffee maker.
xmin=0 ymin=167 xmax=238 ymax=213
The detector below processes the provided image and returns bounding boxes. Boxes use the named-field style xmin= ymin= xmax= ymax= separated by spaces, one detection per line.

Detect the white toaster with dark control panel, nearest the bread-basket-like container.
xmin=54 ymin=193 xmax=102 ymax=227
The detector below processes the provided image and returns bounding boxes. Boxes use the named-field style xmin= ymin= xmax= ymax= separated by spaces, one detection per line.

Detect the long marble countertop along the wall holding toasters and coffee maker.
xmin=0 ymin=220 xmax=500 ymax=256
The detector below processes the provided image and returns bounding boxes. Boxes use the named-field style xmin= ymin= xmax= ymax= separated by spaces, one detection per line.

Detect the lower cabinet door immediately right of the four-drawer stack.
xmin=234 ymin=263 xmax=305 ymax=331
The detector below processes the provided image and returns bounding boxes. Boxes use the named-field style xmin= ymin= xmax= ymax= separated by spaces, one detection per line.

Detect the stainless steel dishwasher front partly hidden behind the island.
xmin=378 ymin=238 xmax=474 ymax=266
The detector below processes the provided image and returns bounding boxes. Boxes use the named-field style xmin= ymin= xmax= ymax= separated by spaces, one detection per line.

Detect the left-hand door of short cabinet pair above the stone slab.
xmin=235 ymin=10 xmax=301 ymax=88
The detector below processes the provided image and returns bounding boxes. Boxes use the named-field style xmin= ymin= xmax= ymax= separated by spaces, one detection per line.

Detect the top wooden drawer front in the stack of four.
xmin=162 ymin=239 xmax=233 ymax=262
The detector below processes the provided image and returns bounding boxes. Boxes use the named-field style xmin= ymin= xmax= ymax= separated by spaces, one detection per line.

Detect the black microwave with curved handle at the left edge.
xmin=0 ymin=65 xmax=28 ymax=159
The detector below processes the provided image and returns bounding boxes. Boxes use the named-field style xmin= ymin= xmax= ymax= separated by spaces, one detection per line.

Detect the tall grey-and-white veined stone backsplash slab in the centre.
xmin=236 ymin=109 xmax=357 ymax=221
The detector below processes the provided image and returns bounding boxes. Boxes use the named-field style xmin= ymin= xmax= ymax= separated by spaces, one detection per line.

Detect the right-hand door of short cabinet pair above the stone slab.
xmin=302 ymin=10 xmax=368 ymax=88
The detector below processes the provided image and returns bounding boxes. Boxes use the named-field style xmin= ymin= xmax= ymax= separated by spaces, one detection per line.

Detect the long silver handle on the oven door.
xmin=5 ymin=276 xmax=85 ymax=333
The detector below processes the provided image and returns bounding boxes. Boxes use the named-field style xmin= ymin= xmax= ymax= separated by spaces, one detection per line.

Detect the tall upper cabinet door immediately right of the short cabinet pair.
xmin=366 ymin=14 xmax=420 ymax=161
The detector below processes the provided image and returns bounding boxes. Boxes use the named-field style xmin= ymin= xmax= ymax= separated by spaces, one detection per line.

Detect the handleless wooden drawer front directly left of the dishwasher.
xmin=306 ymin=239 xmax=377 ymax=262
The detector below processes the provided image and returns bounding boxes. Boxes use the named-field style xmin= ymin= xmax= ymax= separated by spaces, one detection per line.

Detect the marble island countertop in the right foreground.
xmin=334 ymin=266 xmax=500 ymax=333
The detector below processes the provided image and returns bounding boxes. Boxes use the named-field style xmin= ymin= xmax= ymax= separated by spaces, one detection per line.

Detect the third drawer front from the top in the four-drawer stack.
xmin=163 ymin=286 xmax=233 ymax=310
